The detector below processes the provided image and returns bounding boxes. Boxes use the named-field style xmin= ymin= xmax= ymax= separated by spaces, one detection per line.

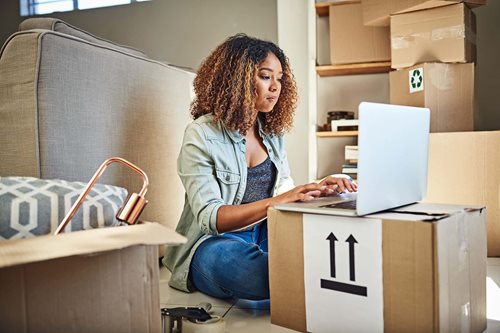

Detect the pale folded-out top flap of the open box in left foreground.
xmin=0 ymin=223 xmax=186 ymax=268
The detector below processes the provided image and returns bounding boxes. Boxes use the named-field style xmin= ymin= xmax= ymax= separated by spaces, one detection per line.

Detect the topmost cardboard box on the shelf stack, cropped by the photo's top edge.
xmin=362 ymin=0 xmax=487 ymax=26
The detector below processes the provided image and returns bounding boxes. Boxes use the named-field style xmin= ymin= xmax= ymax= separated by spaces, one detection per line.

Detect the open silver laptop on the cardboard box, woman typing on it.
xmin=275 ymin=102 xmax=430 ymax=216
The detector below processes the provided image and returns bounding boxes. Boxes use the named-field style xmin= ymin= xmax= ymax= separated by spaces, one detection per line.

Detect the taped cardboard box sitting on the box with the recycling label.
xmin=391 ymin=3 xmax=476 ymax=68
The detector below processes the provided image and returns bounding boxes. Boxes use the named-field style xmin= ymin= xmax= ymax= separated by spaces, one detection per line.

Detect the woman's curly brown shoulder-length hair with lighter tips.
xmin=191 ymin=34 xmax=297 ymax=135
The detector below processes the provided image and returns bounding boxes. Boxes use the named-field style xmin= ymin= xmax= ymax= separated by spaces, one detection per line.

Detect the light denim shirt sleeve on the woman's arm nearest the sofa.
xmin=177 ymin=123 xmax=224 ymax=234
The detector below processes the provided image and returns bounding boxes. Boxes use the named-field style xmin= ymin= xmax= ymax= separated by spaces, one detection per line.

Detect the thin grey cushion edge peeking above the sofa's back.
xmin=19 ymin=17 xmax=147 ymax=57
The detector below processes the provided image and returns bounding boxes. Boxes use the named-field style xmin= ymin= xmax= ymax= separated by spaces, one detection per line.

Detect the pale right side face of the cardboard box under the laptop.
xmin=435 ymin=210 xmax=486 ymax=332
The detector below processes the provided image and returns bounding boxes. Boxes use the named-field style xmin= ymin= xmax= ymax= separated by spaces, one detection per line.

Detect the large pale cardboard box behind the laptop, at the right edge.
xmin=426 ymin=131 xmax=500 ymax=257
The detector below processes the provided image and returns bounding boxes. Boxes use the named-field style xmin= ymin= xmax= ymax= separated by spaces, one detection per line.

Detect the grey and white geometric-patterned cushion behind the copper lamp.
xmin=0 ymin=177 xmax=127 ymax=239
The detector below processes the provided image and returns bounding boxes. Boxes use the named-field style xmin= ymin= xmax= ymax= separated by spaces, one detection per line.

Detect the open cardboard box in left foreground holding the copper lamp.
xmin=0 ymin=223 xmax=185 ymax=332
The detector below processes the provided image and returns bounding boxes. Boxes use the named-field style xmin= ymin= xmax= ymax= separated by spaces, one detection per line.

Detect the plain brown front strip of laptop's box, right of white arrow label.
xmin=382 ymin=220 xmax=438 ymax=332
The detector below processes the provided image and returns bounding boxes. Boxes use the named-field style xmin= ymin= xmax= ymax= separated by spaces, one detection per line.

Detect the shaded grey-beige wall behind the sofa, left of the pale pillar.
xmin=0 ymin=0 xmax=277 ymax=69
